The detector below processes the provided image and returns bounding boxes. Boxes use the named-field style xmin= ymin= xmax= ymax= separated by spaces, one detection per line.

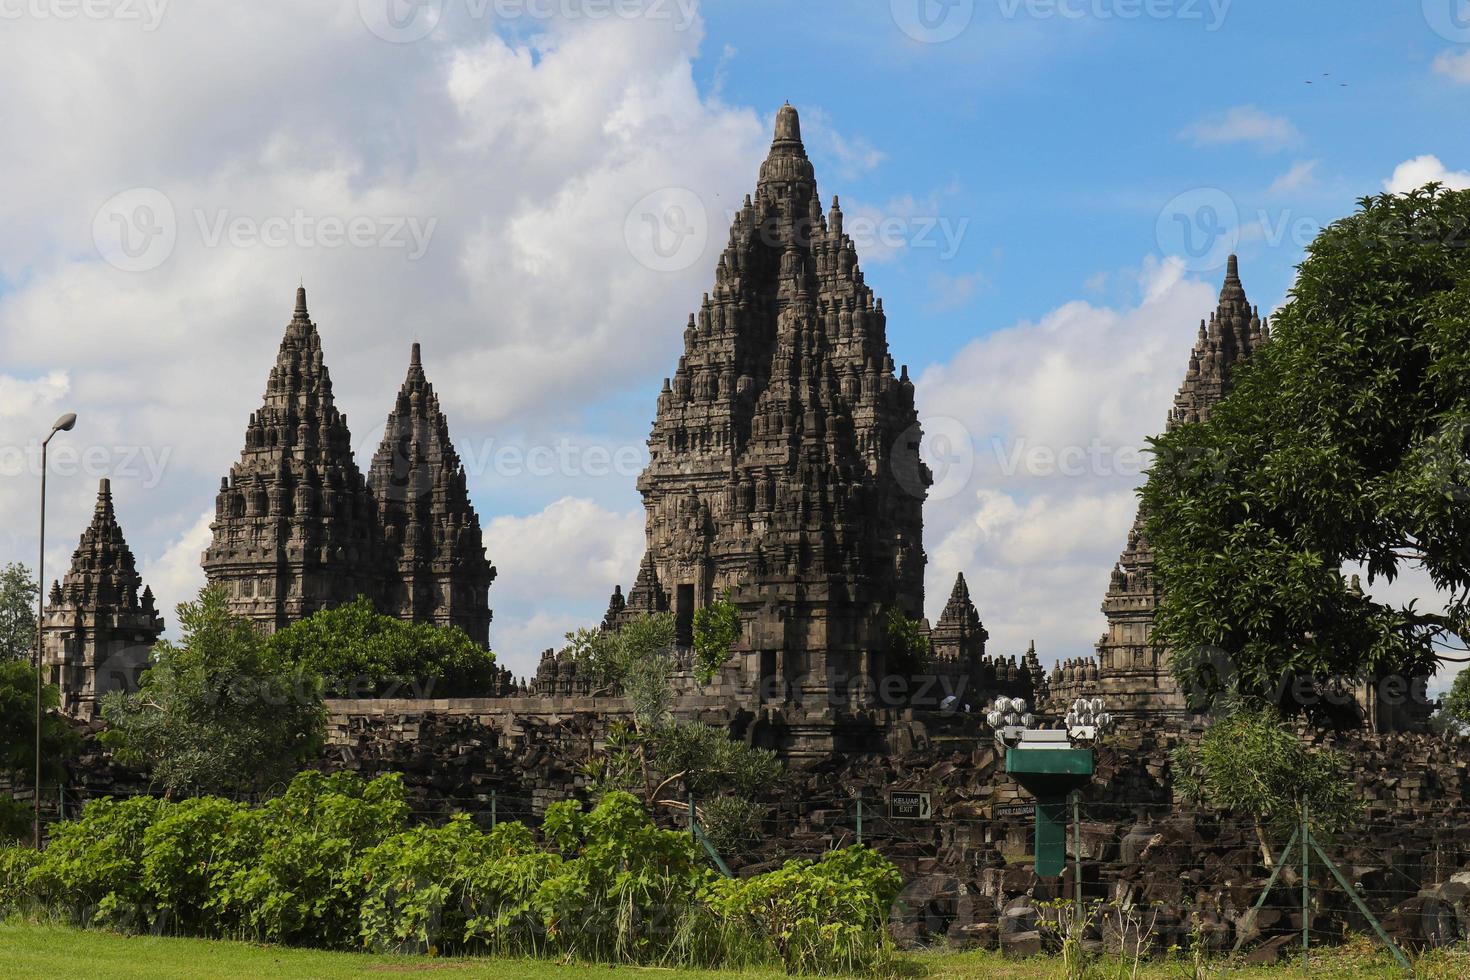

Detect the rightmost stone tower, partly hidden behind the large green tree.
xmin=1093 ymin=256 xmax=1270 ymax=717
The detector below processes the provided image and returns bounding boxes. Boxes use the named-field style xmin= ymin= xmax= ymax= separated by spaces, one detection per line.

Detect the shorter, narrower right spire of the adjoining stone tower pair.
xmin=368 ymin=344 xmax=495 ymax=645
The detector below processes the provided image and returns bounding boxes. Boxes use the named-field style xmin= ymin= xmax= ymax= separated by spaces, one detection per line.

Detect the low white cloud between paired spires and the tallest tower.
xmin=485 ymin=497 xmax=644 ymax=674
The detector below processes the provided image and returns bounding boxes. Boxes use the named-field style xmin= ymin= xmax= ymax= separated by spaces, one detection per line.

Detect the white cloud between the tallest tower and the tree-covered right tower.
xmin=916 ymin=259 xmax=1217 ymax=661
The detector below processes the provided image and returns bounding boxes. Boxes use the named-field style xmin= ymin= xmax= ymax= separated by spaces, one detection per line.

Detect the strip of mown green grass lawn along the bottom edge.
xmin=0 ymin=921 xmax=1470 ymax=980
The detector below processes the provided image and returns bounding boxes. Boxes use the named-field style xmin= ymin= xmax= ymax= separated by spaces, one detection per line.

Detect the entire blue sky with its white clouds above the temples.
xmin=0 ymin=0 xmax=1470 ymax=690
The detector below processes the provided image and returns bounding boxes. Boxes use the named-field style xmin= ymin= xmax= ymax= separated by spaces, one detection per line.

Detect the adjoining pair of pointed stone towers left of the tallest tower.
xmin=203 ymin=288 xmax=495 ymax=645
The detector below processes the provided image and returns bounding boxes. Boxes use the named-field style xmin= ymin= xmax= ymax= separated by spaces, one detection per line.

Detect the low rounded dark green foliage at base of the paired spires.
xmin=266 ymin=595 xmax=495 ymax=698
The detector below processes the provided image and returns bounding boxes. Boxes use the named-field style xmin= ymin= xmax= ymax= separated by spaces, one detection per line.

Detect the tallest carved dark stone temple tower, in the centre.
xmin=628 ymin=106 xmax=931 ymax=738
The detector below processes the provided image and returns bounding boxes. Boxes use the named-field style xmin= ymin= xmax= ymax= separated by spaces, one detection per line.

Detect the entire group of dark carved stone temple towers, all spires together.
xmin=44 ymin=104 xmax=1422 ymax=743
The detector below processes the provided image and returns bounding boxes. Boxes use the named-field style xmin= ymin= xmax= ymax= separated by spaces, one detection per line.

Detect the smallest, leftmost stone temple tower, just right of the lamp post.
xmin=41 ymin=480 xmax=163 ymax=721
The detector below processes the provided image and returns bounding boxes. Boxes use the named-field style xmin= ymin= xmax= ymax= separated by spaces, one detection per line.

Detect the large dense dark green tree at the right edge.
xmin=1144 ymin=185 xmax=1470 ymax=702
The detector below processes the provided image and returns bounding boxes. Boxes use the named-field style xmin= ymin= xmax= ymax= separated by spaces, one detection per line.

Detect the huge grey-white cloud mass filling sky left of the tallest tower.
xmin=0 ymin=0 xmax=776 ymax=654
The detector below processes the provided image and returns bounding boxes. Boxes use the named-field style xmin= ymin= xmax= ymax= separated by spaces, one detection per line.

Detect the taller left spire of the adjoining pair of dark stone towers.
xmin=203 ymin=287 xmax=387 ymax=632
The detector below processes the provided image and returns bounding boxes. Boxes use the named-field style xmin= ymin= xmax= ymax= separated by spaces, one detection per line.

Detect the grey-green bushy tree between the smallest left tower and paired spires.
xmin=103 ymin=589 xmax=325 ymax=796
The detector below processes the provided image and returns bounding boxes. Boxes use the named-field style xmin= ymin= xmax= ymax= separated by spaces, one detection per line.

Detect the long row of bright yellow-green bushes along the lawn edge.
xmin=0 ymin=773 xmax=898 ymax=971
